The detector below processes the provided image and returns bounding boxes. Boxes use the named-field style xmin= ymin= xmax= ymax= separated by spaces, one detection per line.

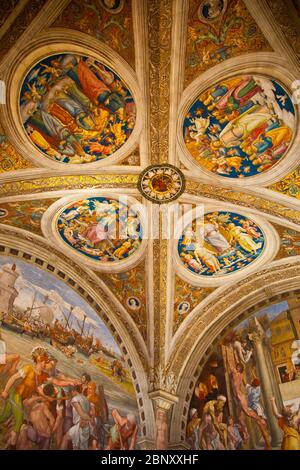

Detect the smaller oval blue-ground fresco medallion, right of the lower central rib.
xmin=178 ymin=211 xmax=265 ymax=277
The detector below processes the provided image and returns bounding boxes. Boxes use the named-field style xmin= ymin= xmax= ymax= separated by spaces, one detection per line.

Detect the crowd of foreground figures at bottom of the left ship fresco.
xmin=0 ymin=346 xmax=138 ymax=450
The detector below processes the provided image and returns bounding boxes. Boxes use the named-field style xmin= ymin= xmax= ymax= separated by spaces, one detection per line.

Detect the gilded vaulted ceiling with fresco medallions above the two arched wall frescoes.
xmin=0 ymin=0 xmax=300 ymax=448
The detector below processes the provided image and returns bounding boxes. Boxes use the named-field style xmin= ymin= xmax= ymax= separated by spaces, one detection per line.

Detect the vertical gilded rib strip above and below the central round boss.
xmin=148 ymin=0 xmax=173 ymax=388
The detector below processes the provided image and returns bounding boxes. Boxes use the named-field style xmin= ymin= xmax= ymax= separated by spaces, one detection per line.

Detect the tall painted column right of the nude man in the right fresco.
xmin=249 ymin=318 xmax=282 ymax=447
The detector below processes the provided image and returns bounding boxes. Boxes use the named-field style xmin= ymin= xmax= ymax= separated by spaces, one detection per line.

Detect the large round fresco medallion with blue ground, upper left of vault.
xmin=20 ymin=53 xmax=136 ymax=164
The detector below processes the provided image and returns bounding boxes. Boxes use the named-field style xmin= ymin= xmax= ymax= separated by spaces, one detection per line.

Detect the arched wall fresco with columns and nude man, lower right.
xmin=186 ymin=301 xmax=300 ymax=451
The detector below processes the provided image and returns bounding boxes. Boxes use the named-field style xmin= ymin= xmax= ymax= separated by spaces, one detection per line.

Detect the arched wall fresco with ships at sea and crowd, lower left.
xmin=0 ymin=257 xmax=139 ymax=450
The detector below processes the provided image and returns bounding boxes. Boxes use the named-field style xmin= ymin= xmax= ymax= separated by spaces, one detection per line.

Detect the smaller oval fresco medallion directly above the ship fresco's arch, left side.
xmin=55 ymin=197 xmax=143 ymax=264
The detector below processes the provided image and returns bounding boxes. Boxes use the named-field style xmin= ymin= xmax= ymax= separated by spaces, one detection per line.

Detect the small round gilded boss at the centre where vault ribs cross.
xmin=138 ymin=164 xmax=185 ymax=204
